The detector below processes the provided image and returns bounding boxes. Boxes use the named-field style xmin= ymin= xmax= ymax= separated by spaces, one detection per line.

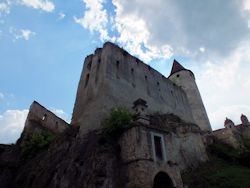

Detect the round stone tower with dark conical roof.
xmin=168 ymin=60 xmax=212 ymax=132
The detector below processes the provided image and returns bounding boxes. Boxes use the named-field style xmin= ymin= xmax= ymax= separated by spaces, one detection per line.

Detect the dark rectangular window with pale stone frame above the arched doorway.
xmin=151 ymin=133 xmax=166 ymax=161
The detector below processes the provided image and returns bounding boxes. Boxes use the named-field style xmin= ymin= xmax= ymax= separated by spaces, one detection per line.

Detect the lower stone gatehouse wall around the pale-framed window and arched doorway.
xmin=119 ymin=123 xmax=207 ymax=188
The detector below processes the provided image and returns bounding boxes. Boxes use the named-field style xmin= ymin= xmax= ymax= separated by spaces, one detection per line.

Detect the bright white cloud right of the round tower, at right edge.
xmin=195 ymin=41 xmax=250 ymax=129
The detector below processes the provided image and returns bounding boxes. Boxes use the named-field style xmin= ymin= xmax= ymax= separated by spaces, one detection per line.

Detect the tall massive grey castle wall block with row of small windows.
xmin=72 ymin=43 xmax=194 ymax=133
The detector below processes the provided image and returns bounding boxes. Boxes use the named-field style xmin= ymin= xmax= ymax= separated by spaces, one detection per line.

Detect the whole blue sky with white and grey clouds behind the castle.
xmin=0 ymin=0 xmax=250 ymax=143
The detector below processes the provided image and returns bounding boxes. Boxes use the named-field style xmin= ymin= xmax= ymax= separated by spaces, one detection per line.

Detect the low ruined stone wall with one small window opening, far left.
xmin=23 ymin=101 xmax=69 ymax=136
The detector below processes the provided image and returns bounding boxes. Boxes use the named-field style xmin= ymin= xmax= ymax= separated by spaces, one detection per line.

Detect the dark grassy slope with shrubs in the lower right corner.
xmin=183 ymin=140 xmax=250 ymax=188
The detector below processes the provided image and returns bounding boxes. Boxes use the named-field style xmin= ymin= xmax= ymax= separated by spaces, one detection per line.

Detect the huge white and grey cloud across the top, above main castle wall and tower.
xmin=74 ymin=0 xmax=249 ymax=62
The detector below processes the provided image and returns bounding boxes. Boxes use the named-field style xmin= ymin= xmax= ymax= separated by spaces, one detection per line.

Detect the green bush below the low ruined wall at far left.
xmin=21 ymin=132 xmax=55 ymax=157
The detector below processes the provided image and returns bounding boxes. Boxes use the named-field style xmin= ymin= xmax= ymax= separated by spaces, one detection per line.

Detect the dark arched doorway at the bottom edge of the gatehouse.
xmin=153 ymin=172 xmax=174 ymax=188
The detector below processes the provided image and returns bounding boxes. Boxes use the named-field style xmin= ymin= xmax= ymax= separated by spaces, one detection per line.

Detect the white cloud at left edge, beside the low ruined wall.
xmin=0 ymin=110 xmax=28 ymax=144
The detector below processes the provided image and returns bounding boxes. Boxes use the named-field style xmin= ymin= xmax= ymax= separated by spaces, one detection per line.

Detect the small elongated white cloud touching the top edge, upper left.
xmin=20 ymin=0 xmax=55 ymax=12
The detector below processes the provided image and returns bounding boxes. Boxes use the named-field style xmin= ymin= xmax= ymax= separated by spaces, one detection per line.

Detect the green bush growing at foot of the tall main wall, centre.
xmin=104 ymin=107 xmax=133 ymax=135
